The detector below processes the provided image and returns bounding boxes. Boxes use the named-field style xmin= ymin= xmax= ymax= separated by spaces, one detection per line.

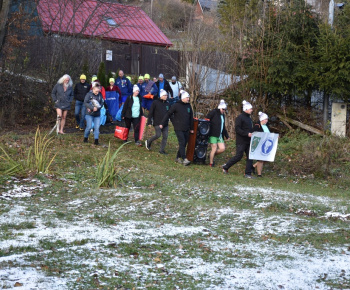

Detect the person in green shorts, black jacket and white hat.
xmin=206 ymin=100 xmax=229 ymax=167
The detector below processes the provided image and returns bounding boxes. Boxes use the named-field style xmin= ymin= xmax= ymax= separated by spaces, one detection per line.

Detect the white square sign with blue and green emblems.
xmin=249 ymin=132 xmax=278 ymax=162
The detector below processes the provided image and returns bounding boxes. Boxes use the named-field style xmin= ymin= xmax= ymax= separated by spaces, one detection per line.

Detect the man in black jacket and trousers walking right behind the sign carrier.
xmin=222 ymin=101 xmax=253 ymax=178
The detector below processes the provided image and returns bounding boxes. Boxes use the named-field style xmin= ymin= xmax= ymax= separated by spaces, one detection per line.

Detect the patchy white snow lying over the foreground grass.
xmin=0 ymin=186 xmax=350 ymax=289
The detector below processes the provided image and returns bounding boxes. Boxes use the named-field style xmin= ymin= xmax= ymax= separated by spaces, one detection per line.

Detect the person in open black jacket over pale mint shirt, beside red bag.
xmin=122 ymin=85 xmax=143 ymax=146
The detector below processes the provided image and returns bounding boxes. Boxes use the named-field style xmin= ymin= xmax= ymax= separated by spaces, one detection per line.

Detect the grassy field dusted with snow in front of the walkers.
xmin=0 ymin=127 xmax=350 ymax=289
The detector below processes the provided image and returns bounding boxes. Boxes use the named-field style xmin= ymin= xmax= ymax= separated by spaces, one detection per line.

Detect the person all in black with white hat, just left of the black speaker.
xmin=159 ymin=90 xmax=193 ymax=166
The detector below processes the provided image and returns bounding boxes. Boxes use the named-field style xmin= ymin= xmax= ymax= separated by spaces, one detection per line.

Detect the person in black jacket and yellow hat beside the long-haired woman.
xmin=74 ymin=74 xmax=90 ymax=131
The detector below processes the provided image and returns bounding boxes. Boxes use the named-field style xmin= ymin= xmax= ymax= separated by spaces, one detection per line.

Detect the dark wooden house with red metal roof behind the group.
xmin=15 ymin=0 xmax=179 ymax=79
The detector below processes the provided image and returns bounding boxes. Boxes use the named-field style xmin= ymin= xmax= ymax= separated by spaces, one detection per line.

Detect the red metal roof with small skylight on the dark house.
xmin=38 ymin=0 xmax=173 ymax=46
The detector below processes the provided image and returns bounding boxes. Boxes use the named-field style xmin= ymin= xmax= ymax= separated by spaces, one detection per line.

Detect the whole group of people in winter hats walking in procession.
xmin=52 ymin=71 xmax=269 ymax=178
